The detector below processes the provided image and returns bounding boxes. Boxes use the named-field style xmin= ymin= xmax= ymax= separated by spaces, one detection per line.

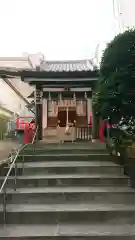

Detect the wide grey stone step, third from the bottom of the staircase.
xmin=0 ymin=186 xmax=135 ymax=204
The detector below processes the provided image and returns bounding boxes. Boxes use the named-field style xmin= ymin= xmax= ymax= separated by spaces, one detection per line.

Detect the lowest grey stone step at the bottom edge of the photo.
xmin=0 ymin=224 xmax=135 ymax=240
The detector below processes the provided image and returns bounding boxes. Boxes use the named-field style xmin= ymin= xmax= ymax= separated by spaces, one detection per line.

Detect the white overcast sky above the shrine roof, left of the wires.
xmin=0 ymin=0 xmax=120 ymax=59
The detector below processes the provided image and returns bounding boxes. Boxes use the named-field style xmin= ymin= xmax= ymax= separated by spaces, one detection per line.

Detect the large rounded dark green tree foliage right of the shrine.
xmin=93 ymin=29 xmax=135 ymax=123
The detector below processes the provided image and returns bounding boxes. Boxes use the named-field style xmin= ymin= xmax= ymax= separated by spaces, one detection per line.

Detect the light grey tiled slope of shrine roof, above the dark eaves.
xmin=40 ymin=60 xmax=95 ymax=72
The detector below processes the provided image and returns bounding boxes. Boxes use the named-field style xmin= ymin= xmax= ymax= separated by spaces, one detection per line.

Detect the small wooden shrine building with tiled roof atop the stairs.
xmin=0 ymin=60 xmax=98 ymax=140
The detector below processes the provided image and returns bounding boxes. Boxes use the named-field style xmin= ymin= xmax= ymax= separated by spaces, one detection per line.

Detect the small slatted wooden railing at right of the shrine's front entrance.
xmin=76 ymin=125 xmax=91 ymax=141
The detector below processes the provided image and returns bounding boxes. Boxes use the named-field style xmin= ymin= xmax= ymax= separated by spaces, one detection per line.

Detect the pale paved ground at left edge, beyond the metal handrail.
xmin=0 ymin=140 xmax=20 ymax=163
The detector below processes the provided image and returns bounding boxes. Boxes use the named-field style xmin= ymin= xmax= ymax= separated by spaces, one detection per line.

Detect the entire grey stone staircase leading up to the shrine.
xmin=0 ymin=143 xmax=135 ymax=240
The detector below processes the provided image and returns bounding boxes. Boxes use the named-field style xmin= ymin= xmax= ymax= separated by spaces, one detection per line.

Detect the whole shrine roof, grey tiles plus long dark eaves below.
xmin=0 ymin=60 xmax=99 ymax=84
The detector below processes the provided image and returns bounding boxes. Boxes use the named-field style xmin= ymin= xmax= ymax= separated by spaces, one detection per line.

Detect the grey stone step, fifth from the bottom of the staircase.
xmin=7 ymin=161 xmax=123 ymax=175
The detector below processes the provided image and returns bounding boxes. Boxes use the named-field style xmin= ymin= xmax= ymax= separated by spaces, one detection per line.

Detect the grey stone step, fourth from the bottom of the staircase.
xmin=0 ymin=174 xmax=129 ymax=188
